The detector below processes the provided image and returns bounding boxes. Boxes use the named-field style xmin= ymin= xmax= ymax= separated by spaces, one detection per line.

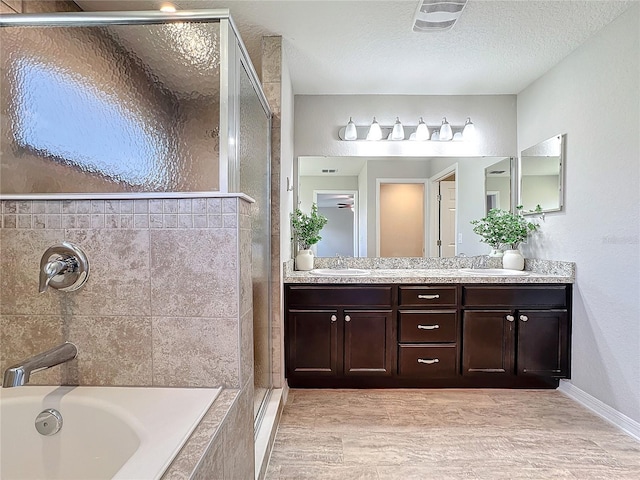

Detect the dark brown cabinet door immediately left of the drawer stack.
xmin=344 ymin=310 xmax=394 ymax=376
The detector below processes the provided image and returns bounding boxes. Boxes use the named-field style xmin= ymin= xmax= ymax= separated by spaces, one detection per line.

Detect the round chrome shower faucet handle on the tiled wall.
xmin=39 ymin=242 xmax=89 ymax=293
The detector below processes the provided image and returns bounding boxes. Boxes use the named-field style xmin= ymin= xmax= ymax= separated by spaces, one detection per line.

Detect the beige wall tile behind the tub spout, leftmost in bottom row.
xmin=0 ymin=315 xmax=67 ymax=385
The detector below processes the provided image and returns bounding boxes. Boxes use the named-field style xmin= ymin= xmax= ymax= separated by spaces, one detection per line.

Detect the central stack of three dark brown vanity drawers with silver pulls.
xmin=398 ymin=286 xmax=459 ymax=379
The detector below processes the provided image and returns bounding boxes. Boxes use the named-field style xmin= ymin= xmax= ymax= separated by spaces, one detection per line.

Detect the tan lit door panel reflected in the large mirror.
xmin=379 ymin=183 xmax=425 ymax=257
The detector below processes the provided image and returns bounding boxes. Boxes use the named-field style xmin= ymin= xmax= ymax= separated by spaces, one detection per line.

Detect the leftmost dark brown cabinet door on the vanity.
xmin=287 ymin=310 xmax=338 ymax=376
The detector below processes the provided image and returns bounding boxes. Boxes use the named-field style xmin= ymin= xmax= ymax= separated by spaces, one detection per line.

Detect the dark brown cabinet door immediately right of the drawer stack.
xmin=462 ymin=310 xmax=515 ymax=375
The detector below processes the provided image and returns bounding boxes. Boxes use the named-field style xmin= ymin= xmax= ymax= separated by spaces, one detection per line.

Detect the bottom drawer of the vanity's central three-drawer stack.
xmin=398 ymin=345 xmax=458 ymax=378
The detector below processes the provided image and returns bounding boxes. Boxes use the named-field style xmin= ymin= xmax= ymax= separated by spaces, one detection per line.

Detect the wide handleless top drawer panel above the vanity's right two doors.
xmin=462 ymin=285 xmax=568 ymax=308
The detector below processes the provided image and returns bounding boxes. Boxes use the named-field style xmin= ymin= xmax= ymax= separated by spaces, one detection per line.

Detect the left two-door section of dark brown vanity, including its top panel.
xmin=285 ymin=285 xmax=395 ymax=386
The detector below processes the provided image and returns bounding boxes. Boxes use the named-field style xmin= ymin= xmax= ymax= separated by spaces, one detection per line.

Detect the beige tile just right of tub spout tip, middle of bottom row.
xmin=65 ymin=315 xmax=152 ymax=386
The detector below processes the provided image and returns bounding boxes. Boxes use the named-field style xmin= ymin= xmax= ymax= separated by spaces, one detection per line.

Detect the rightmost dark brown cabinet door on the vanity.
xmin=516 ymin=310 xmax=569 ymax=378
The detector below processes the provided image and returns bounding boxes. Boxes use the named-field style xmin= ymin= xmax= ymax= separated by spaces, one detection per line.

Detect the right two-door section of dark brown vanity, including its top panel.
xmin=462 ymin=285 xmax=571 ymax=378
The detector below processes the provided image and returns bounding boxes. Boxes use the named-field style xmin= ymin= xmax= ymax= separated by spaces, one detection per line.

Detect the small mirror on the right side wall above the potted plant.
xmin=518 ymin=135 xmax=565 ymax=212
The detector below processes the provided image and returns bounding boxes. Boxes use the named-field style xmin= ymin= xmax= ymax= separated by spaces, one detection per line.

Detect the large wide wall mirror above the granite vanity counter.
xmin=295 ymin=156 xmax=513 ymax=257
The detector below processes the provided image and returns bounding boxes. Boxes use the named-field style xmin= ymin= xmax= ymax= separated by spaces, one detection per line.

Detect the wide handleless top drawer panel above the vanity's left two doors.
xmin=286 ymin=285 xmax=392 ymax=308
